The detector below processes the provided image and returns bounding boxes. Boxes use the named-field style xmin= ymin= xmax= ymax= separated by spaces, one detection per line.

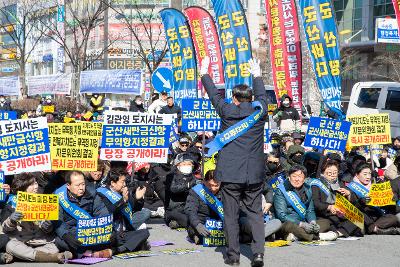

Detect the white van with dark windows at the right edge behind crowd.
xmin=347 ymin=82 xmax=400 ymax=138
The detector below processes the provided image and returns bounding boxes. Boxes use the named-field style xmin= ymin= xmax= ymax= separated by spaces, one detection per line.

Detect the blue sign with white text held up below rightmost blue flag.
xmin=304 ymin=117 xmax=351 ymax=152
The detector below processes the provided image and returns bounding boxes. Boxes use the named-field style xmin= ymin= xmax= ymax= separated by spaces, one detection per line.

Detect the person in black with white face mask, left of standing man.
xmin=165 ymin=153 xmax=196 ymax=229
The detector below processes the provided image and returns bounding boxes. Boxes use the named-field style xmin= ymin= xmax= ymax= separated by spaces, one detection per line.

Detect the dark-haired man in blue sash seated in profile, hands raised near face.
xmin=93 ymin=170 xmax=150 ymax=254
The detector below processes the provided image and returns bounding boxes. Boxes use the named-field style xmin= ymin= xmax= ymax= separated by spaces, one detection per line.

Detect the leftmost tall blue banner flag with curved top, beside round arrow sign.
xmin=160 ymin=8 xmax=197 ymax=102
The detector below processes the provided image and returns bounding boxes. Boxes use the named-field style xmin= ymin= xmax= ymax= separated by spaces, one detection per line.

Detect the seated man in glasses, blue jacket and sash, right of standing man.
xmin=274 ymin=165 xmax=329 ymax=241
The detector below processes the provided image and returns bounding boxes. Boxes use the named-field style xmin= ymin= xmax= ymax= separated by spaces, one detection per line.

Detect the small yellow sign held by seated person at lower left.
xmin=15 ymin=191 xmax=58 ymax=221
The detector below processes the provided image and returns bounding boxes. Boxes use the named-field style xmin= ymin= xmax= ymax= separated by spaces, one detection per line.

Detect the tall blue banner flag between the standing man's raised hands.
xmin=211 ymin=0 xmax=252 ymax=100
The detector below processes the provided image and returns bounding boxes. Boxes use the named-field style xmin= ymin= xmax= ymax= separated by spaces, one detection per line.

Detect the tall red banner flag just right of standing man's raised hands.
xmin=265 ymin=0 xmax=303 ymax=116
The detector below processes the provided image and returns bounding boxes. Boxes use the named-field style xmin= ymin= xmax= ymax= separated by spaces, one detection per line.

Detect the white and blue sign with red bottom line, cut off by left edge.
xmin=0 ymin=117 xmax=51 ymax=175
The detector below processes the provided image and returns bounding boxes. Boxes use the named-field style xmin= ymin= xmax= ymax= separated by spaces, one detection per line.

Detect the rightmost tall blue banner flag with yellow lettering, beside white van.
xmin=299 ymin=0 xmax=343 ymax=117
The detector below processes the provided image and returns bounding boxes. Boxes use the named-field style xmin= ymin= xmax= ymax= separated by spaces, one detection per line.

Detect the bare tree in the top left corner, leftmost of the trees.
xmin=0 ymin=0 xmax=49 ymax=94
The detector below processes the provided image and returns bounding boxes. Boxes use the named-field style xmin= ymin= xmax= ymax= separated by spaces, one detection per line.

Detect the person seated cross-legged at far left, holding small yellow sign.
xmin=2 ymin=173 xmax=72 ymax=263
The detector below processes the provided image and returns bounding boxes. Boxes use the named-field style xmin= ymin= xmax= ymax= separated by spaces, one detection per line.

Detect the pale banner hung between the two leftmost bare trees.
xmin=26 ymin=74 xmax=72 ymax=95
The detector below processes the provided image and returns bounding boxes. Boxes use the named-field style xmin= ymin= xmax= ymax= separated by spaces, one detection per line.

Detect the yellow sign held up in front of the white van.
xmin=347 ymin=113 xmax=392 ymax=147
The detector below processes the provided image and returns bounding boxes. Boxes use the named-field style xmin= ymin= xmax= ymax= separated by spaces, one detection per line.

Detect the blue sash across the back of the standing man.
xmin=206 ymin=101 xmax=264 ymax=157
